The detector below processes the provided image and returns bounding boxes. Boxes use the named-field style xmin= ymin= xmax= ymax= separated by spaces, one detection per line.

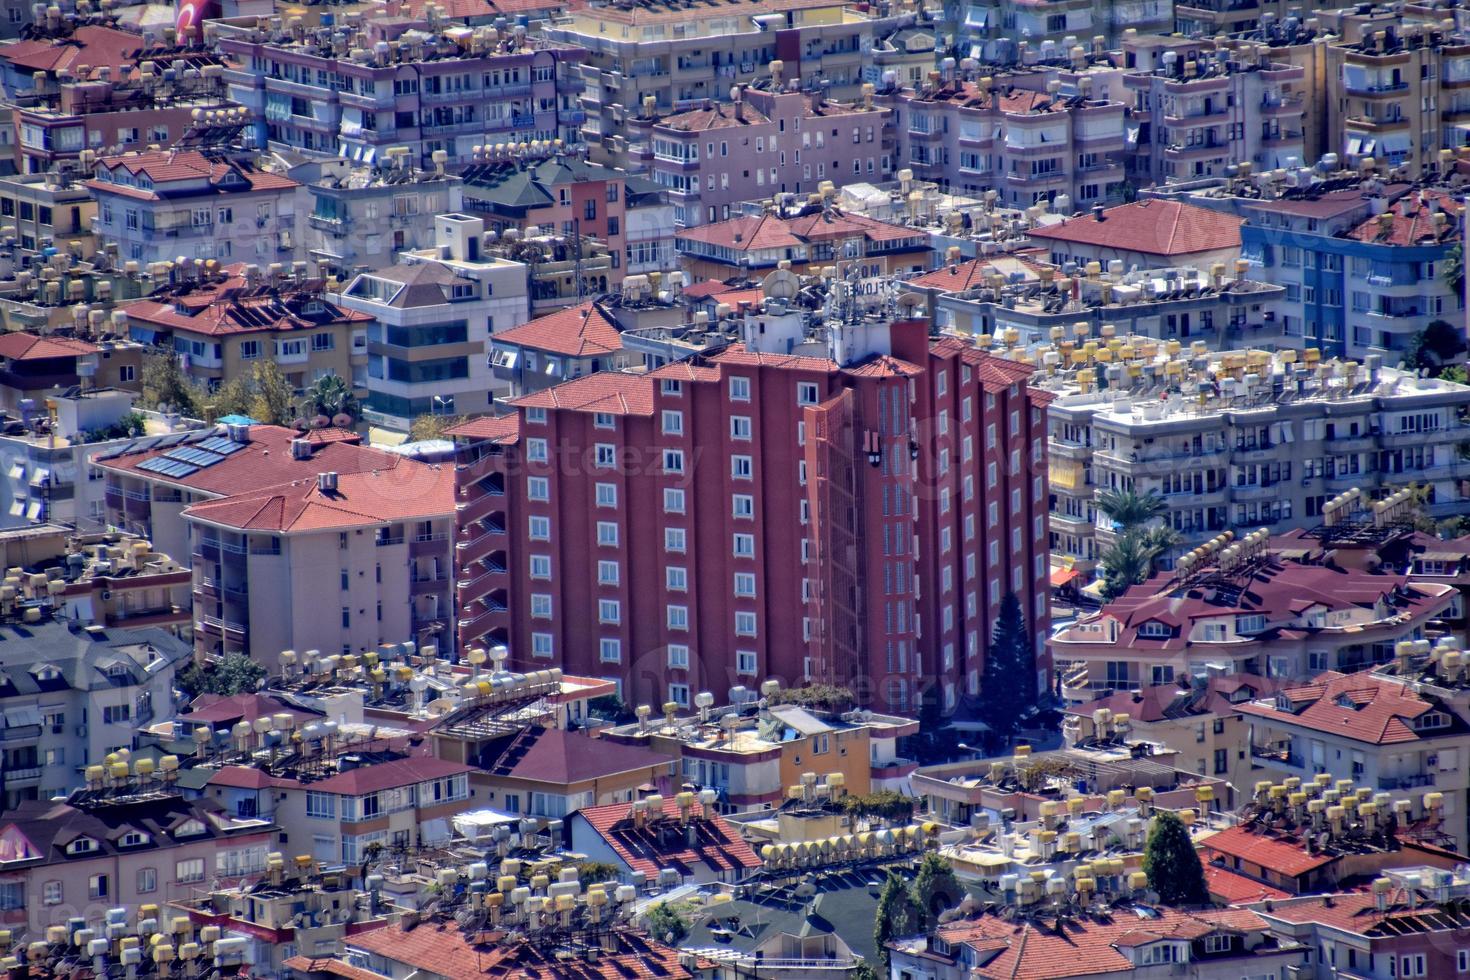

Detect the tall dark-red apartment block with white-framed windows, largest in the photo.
xmin=454 ymin=310 xmax=1048 ymax=714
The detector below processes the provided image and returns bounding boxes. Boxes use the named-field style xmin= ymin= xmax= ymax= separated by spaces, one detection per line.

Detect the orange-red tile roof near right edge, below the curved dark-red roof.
xmin=1235 ymin=671 xmax=1435 ymax=745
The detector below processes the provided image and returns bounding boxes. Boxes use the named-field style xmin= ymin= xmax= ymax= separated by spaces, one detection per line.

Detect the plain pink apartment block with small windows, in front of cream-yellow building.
xmin=628 ymin=81 xmax=894 ymax=228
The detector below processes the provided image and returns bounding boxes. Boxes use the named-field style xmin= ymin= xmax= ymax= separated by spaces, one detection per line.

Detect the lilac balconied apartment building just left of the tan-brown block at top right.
xmin=1123 ymin=38 xmax=1307 ymax=184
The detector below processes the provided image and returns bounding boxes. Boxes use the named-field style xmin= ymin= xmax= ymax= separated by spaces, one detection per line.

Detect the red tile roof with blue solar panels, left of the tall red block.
xmin=93 ymin=425 xmax=408 ymax=497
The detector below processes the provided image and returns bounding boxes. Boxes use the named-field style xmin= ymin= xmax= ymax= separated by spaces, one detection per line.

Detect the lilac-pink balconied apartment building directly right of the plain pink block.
xmin=881 ymin=72 xmax=1127 ymax=208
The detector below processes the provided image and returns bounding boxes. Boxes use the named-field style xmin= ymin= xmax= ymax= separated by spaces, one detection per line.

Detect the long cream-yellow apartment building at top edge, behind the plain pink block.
xmin=545 ymin=0 xmax=917 ymax=163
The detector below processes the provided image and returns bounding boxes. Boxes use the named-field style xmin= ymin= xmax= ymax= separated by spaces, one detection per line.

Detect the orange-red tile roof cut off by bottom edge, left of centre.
xmin=338 ymin=920 xmax=692 ymax=980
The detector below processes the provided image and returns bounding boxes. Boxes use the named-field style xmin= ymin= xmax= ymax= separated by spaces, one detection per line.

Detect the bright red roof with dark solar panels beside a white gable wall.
xmin=576 ymin=798 xmax=760 ymax=879
